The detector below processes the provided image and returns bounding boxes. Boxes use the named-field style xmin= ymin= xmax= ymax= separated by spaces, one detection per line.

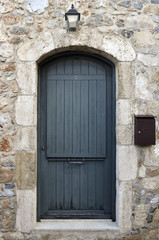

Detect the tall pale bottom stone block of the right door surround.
xmin=117 ymin=182 xmax=132 ymax=233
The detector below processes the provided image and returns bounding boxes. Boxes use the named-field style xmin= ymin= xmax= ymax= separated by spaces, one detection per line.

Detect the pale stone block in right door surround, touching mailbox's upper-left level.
xmin=117 ymin=99 xmax=132 ymax=125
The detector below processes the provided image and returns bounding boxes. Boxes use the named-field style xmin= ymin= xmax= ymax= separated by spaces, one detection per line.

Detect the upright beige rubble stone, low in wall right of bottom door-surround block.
xmin=134 ymin=204 xmax=147 ymax=227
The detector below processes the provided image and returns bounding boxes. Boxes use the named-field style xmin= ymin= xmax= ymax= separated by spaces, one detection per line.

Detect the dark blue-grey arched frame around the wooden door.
xmin=37 ymin=51 xmax=116 ymax=222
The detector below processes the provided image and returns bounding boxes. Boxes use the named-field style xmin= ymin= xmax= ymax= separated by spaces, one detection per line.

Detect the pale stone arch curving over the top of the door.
xmin=17 ymin=30 xmax=136 ymax=62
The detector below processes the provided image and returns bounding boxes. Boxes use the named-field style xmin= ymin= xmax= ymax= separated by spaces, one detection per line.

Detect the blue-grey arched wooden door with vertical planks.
xmin=38 ymin=52 xmax=115 ymax=220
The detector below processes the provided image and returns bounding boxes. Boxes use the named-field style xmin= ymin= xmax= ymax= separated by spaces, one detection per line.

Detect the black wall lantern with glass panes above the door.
xmin=65 ymin=4 xmax=80 ymax=31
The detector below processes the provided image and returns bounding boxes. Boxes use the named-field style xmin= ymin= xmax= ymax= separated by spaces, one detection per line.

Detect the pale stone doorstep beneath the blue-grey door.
xmin=35 ymin=219 xmax=119 ymax=231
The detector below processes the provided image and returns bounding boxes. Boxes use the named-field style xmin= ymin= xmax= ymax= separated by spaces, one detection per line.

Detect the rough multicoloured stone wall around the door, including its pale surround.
xmin=0 ymin=0 xmax=159 ymax=240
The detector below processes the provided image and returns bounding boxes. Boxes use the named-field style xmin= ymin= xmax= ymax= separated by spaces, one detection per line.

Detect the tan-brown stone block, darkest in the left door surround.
xmin=16 ymin=152 xmax=35 ymax=190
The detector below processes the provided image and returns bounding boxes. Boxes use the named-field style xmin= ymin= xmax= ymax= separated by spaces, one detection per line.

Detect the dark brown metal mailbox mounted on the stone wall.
xmin=135 ymin=115 xmax=156 ymax=145
